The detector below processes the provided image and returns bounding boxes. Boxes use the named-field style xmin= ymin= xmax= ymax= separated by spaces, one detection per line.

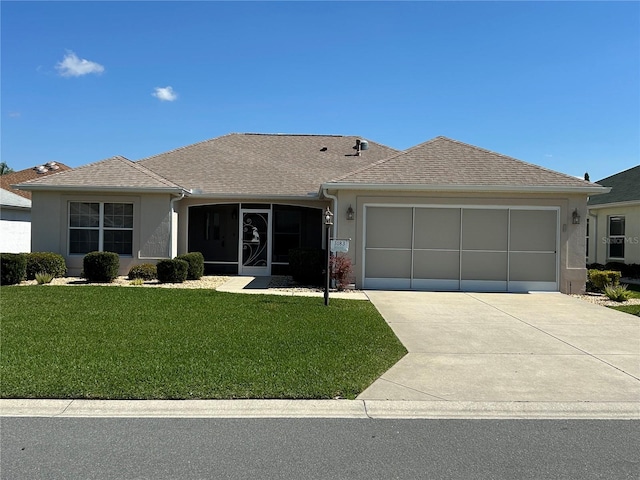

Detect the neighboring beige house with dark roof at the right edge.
xmin=586 ymin=165 xmax=640 ymax=264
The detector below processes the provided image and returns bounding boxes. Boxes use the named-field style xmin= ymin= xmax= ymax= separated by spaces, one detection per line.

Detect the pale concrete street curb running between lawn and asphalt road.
xmin=0 ymin=399 xmax=640 ymax=420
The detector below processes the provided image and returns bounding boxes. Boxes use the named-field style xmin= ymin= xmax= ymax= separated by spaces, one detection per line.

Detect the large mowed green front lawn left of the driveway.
xmin=0 ymin=286 xmax=406 ymax=399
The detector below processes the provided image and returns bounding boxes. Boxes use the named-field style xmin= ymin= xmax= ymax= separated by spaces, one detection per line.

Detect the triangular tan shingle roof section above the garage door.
xmin=331 ymin=137 xmax=599 ymax=190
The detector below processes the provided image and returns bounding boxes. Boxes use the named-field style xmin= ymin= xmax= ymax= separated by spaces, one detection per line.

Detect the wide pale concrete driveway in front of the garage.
xmin=358 ymin=291 xmax=640 ymax=402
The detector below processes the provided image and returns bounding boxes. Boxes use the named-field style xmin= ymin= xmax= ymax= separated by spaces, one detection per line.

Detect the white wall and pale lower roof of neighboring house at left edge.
xmin=0 ymin=188 xmax=31 ymax=253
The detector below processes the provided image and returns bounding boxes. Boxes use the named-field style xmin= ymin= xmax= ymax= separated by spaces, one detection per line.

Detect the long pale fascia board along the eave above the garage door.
xmin=320 ymin=183 xmax=611 ymax=195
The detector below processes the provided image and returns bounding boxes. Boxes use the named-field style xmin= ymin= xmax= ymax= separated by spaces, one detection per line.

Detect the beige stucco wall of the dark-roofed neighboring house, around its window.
xmin=588 ymin=202 xmax=640 ymax=264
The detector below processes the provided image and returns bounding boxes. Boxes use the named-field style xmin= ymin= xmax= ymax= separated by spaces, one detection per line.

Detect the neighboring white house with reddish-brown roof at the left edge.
xmin=0 ymin=162 xmax=70 ymax=253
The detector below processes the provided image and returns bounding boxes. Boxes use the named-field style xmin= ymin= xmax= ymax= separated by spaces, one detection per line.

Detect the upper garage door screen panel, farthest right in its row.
xmin=510 ymin=210 xmax=557 ymax=252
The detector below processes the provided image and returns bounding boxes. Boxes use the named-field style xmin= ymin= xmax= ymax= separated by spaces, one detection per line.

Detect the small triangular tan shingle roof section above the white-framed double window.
xmin=19 ymin=156 xmax=182 ymax=191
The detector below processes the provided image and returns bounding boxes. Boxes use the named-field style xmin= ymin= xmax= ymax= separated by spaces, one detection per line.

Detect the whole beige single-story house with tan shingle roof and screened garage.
xmin=13 ymin=134 xmax=608 ymax=292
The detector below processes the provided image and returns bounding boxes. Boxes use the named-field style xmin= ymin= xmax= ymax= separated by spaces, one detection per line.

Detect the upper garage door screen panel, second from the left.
xmin=414 ymin=208 xmax=460 ymax=250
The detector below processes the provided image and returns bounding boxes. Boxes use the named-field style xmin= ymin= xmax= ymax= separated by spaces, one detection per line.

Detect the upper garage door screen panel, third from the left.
xmin=462 ymin=208 xmax=509 ymax=251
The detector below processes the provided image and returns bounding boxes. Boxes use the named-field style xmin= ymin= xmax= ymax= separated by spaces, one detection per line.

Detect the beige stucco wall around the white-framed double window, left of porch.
xmin=31 ymin=191 xmax=172 ymax=276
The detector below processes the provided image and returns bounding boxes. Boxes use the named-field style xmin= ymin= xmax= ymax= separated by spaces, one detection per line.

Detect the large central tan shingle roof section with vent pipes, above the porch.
xmin=138 ymin=133 xmax=397 ymax=197
